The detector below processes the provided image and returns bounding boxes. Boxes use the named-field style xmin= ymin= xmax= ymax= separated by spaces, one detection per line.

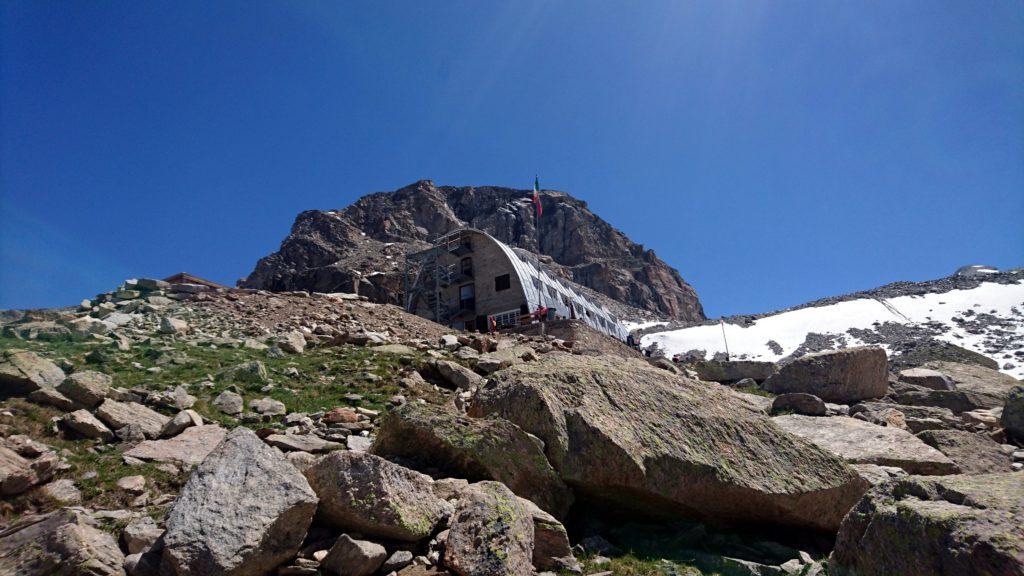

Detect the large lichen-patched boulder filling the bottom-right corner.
xmin=828 ymin=472 xmax=1024 ymax=576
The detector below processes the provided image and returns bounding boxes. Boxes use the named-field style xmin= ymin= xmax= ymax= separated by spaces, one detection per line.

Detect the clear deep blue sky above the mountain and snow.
xmin=0 ymin=0 xmax=1024 ymax=316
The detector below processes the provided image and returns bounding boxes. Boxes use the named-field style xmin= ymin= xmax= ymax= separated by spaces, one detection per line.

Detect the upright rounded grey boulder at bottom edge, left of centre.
xmin=444 ymin=482 xmax=534 ymax=576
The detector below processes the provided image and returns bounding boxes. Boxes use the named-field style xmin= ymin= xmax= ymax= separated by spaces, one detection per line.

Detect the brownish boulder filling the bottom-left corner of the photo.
xmin=0 ymin=508 xmax=125 ymax=576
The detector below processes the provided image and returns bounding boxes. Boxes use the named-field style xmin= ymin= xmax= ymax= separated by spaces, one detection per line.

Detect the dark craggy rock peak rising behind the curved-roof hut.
xmin=240 ymin=180 xmax=705 ymax=321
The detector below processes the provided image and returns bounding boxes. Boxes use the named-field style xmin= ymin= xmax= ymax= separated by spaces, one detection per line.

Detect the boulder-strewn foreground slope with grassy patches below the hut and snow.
xmin=0 ymin=280 xmax=1024 ymax=576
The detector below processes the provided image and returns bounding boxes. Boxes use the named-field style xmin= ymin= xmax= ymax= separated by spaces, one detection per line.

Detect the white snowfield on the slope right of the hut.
xmin=640 ymin=282 xmax=1024 ymax=378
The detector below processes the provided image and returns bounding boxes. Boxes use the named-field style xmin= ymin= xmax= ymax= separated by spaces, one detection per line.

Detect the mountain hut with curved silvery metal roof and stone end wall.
xmin=402 ymin=228 xmax=628 ymax=340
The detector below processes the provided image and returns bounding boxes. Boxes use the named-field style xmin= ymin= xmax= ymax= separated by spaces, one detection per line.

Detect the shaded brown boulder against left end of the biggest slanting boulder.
xmin=372 ymin=403 xmax=572 ymax=518
